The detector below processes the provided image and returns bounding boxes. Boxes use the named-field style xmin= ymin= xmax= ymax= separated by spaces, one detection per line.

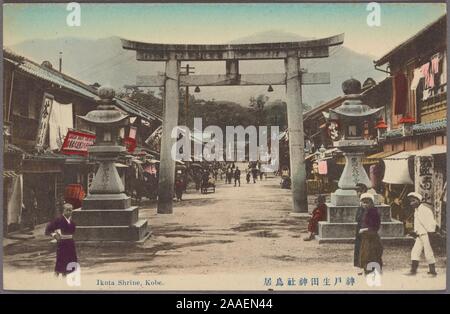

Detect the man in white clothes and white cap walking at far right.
xmin=408 ymin=192 xmax=437 ymax=276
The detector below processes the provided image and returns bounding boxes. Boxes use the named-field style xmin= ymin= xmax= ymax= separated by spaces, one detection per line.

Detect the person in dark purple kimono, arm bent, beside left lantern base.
xmin=45 ymin=203 xmax=77 ymax=276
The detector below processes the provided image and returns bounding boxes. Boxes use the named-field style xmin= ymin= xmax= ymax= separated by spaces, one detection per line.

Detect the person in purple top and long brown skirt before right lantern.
xmin=358 ymin=193 xmax=383 ymax=274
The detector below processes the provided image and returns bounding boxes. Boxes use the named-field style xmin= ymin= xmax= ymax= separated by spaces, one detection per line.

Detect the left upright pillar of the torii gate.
xmin=157 ymin=57 xmax=180 ymax=214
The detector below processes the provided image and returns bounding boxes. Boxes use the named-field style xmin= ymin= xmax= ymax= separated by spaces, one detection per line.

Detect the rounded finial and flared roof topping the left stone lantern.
xmin=79 ymin=87 xmax=129 ymax=125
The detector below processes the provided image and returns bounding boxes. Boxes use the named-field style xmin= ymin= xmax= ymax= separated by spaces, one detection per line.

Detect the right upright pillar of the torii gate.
xmin=285 ymin=53 xmax=308 ymax=213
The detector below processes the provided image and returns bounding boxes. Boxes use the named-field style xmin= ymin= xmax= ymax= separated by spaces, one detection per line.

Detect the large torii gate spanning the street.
xmin=122 ymin=34 xmax=344 ymax=214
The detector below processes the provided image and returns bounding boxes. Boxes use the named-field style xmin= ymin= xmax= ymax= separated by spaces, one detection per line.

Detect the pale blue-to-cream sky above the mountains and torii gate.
xmin=3 ymin=3 xmax=446 ymax=58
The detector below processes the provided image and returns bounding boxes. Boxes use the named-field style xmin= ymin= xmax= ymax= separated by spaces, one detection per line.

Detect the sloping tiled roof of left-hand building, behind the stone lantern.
xmin=3 ymin=49 xmax=162 ymax=121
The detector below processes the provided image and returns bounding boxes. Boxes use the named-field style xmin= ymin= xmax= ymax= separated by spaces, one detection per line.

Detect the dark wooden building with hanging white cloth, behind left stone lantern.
xmin=3 ymin=49 xmax=161 ymax=234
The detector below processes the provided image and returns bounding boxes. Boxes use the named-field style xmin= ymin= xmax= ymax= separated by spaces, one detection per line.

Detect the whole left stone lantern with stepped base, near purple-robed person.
xmin=73 ymin=87 xmax=149 ymax=241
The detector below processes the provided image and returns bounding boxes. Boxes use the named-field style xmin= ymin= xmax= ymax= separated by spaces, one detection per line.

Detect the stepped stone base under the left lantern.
xmin=72 ymin=193 xmax=149 ymax=242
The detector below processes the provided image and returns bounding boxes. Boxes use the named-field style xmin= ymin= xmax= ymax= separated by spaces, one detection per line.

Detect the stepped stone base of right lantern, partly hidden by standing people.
xmin=316 ymin=203 xmax=406 ymax=243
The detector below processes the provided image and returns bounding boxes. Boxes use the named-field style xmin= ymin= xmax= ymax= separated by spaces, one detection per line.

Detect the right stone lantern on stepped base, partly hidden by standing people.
xmin=318 ymin=79 xmax=403 ymax=242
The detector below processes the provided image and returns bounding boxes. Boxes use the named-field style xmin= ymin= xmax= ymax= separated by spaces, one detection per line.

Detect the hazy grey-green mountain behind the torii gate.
xmin=8 ymin=31 xmax=385 ymax=106
